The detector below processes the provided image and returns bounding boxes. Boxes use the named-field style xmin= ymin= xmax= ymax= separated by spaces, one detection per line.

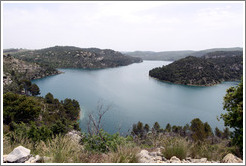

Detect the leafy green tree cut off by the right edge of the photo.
xmin=221 ymin=78 xmax=243 ymax=152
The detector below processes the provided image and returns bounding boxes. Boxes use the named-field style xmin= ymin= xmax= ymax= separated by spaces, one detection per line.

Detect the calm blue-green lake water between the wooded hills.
xmin=32 ymin=61 xmax=238 ymax=133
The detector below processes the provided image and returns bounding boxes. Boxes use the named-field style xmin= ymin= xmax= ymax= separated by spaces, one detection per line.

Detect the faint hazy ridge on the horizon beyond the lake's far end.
xmin=124 ymin=47 xmax=243 ymax=61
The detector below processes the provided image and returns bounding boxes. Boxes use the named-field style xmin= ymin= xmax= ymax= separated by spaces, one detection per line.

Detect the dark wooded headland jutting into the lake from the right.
xmin=149 ymin=51 xmax=243 ymax=86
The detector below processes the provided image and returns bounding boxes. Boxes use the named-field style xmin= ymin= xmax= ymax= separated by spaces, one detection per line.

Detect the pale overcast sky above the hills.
xmin=2 ymin=1 xmax=245 ymax=51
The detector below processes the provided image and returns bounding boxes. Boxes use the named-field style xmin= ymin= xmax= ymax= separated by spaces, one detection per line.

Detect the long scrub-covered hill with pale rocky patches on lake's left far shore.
xmin=8 ymin=46 xmax=142 ymax=69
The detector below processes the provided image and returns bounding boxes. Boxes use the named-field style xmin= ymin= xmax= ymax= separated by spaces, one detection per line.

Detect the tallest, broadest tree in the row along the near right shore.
xmin=190 ymin=118 xmax=206 ymax=141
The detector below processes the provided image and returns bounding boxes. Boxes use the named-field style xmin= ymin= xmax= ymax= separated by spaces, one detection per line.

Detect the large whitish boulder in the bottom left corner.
xmin=6 ymin=146 xmax=31 ymax=163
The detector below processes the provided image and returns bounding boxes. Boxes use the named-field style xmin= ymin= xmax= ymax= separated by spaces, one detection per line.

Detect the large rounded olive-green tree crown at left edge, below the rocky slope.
xmin=3 ymin=92 xmax=41 ymax=124
